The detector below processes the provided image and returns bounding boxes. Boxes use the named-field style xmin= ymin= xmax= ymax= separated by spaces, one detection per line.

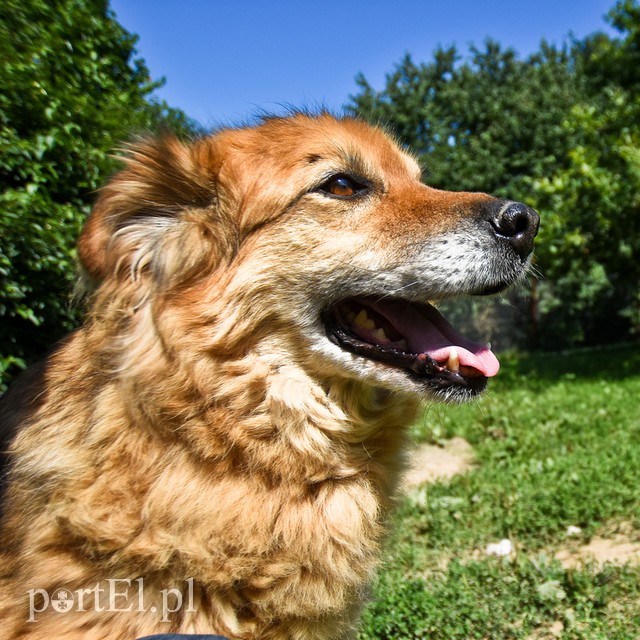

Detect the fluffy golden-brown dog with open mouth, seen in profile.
xmin=0 ymin=113 xmax=539 ymax=640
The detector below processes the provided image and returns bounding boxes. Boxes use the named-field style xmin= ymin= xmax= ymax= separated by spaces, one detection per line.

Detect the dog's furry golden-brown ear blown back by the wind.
xmin=78 ymin=138 xmax=236 ymax=283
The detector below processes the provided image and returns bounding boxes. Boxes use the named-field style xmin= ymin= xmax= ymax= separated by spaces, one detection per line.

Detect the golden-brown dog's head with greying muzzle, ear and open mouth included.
xmin=79 ymin=114 xmax=538 ymax=399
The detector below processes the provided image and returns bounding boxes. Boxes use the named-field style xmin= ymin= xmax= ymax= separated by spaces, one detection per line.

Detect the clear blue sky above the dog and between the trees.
xmin=111 ymin=0 xmax=614 ymax=126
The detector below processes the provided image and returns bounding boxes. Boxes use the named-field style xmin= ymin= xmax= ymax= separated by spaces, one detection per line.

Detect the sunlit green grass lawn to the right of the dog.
xmin=359 ymin=346 xmax=640 ymax=640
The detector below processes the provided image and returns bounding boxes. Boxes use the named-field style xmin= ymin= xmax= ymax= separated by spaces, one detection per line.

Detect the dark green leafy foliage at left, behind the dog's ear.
xmin=0 ymin=0 xmax=200 ymax=390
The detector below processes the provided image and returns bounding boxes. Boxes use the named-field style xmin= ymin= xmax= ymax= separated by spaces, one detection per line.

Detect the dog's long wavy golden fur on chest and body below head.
xmin=0 ymin=332 xmax=414 ymax=639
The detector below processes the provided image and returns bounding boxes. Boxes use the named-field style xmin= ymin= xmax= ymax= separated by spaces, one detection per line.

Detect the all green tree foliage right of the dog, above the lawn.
xmin=348 ymin=0 xmax=640 ymax=347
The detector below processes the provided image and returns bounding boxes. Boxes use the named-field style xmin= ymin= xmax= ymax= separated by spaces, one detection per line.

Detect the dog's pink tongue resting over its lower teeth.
xmin=373 ymin=300 xmax=500 ymax=378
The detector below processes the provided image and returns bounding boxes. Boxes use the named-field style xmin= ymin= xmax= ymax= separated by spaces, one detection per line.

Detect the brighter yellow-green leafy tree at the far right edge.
xmin=532 ymin=0 xmax=640 ymax=343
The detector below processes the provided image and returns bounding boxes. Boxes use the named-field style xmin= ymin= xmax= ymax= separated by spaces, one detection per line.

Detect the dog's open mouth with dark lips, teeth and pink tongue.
xmin=322 ymin=298 xmax=500 ymax=396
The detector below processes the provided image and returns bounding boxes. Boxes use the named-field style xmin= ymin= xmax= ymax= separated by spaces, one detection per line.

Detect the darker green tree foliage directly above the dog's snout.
xmin=350 ymin=40 xmax=580 ymax=199
